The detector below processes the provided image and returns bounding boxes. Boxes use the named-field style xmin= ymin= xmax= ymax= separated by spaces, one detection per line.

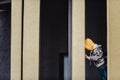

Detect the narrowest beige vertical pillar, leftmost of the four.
xmin=10 ymin=0 xmax=22 ymax=80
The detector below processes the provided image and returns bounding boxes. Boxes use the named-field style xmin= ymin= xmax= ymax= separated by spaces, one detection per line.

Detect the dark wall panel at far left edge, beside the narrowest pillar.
xmin=0 ymin=4 xmax=11 ymax=80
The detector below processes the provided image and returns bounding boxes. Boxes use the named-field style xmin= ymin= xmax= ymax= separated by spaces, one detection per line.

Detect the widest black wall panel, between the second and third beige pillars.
xmin=40 ymin=0 xmax=68 ymax=80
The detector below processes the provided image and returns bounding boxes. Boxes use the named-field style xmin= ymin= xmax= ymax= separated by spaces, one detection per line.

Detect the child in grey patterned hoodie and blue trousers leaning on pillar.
xmin=85 ymin=38 xmax=107 ymax=80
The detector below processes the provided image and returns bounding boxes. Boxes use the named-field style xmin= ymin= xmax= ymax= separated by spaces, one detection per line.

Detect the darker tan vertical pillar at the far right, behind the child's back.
xmin=107 ymin=0 xmax=120 ymax=80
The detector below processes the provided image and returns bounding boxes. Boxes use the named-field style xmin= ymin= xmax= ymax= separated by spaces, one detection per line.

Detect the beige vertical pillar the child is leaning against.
xmin=72 ymin=0 xmax=85 ymax=80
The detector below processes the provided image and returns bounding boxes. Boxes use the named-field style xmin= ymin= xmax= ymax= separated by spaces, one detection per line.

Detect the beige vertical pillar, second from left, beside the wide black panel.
xmin=23 ymin=0 xmax=40 ymax=80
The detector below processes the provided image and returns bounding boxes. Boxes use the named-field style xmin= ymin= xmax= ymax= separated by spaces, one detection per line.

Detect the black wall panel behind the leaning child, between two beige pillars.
xmin=85 ymin=0 xmax=107 ymax=80
